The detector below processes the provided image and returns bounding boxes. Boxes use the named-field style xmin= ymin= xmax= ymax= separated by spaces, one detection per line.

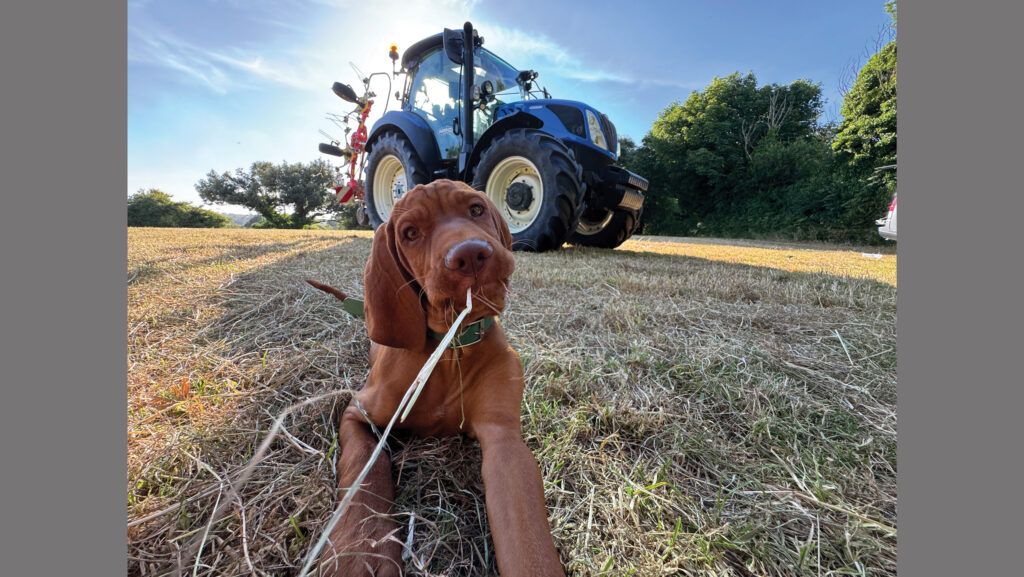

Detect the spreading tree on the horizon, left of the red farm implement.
xmin=196 ymin=160 xmax=340 ymax=229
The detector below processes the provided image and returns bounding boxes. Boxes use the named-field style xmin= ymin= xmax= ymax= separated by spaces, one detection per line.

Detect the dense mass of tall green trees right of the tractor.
xmin=621 ymin=57 xmax=896 ymax=243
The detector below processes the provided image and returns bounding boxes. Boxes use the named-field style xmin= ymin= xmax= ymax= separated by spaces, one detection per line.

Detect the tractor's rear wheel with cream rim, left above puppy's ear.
xmin=366 ymin=132 xmax=430 ymax=230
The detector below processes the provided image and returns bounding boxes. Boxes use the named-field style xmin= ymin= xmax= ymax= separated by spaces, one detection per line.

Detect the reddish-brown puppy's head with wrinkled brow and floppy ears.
xmin=364 ymin=179 xmax=515 ymax=349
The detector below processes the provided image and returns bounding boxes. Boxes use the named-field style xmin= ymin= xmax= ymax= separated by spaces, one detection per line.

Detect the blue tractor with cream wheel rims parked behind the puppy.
xmin=321 ymin=23 xmax=647 ymax=251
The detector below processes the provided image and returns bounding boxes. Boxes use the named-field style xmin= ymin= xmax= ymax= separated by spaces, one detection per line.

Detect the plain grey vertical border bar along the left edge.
xmin=0 ymin=1 xmax=127 ymax=577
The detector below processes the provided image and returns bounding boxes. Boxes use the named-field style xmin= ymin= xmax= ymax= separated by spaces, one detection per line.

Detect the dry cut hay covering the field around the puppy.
xmin=127 ymin=229 xmax=896 ymax=576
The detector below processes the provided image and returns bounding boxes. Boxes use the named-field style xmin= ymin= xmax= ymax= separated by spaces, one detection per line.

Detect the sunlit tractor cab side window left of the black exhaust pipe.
xmin=412 ymin=50 xmax=462 ymax=159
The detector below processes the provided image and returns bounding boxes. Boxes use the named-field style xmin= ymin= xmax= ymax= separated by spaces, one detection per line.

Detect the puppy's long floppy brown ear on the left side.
xmin=362 ymin=219 xmax=427 ymax=351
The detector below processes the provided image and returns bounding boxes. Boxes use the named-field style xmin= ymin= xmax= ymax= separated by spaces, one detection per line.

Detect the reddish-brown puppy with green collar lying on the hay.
xmin=310 ymin=180 xmax=564 ymax=577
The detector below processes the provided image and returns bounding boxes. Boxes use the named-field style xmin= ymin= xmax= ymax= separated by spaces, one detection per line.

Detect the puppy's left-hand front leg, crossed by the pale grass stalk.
xmin=321 ymin=400 xmax=402 ymax=577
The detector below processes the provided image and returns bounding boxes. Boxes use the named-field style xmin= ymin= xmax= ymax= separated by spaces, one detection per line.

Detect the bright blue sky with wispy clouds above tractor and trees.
xmin=127 ymin=0 xmax=891 ymax=212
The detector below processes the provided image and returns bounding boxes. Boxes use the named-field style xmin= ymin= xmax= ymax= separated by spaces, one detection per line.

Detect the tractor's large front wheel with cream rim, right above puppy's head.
xmin=472 ymin=128 xmax=585 ymax=252
